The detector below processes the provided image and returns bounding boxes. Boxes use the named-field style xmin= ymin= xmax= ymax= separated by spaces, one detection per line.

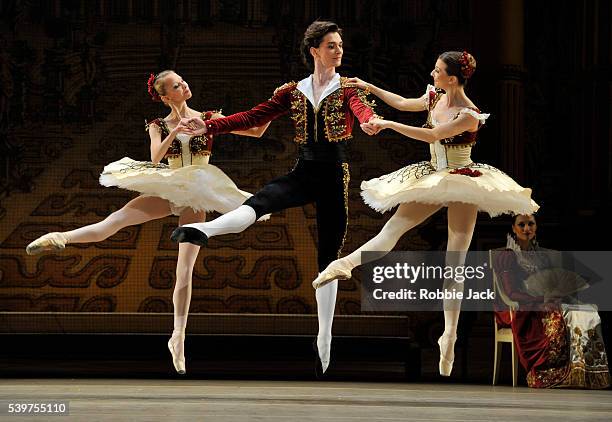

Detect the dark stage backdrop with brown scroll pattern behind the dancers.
xmin=0 ymin=0 xmax=612 ymax=342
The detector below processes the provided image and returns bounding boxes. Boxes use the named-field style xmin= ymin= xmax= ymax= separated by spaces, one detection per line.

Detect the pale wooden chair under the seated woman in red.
xmin=489 ymin=248 xmax=518 ymax=387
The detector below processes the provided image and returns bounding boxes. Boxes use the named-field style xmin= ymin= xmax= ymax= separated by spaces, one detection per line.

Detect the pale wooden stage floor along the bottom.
xmin=0 ymin=379 xmax=612 ymax=422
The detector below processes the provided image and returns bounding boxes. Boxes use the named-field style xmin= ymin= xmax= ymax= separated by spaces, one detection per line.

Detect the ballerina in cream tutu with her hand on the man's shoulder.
xmin=312 ymin=51 xmax=539 ymax=376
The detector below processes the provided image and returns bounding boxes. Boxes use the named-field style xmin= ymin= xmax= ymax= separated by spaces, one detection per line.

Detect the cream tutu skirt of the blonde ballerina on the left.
xmin=100 ymin=157 xmax=263 ymax=219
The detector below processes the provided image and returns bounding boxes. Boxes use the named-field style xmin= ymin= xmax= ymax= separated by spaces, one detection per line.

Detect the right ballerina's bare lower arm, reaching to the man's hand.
xmin=367 ymin=113 xmax=478 ymax=144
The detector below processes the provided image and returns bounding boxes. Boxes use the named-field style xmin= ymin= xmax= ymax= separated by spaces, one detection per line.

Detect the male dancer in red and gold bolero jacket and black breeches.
xmin=172 ymin=21 xmax=375 ymax=373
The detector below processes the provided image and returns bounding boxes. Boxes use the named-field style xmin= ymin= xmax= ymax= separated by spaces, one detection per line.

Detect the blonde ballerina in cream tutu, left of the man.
xmin=26 ymin=70 xmax=269 ymax=374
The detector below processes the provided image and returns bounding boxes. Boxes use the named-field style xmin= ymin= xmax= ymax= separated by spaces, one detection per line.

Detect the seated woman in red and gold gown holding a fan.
xmin=494 ymin=215 xmax=610 ymax=389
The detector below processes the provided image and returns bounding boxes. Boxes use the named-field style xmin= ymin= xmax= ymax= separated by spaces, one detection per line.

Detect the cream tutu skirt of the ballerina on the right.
xmin=361 ymin=161 xmax=539 ymax=217
